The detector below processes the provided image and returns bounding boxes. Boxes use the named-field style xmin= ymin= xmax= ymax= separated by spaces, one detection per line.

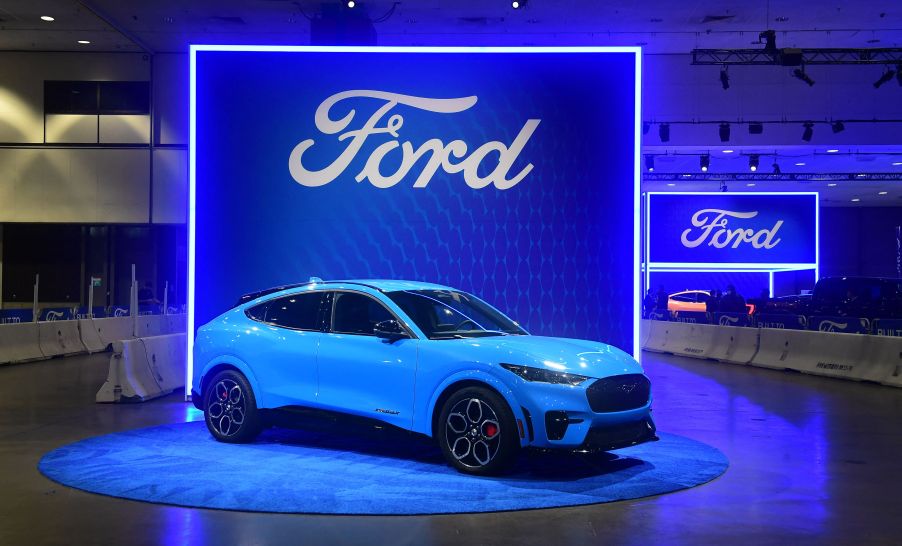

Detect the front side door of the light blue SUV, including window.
xmin=317 ymin=291 xmax=418 ymax=428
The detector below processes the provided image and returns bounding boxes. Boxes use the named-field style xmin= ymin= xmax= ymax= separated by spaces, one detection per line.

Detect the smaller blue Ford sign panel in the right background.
xmin=646 ymin=192 xmax=818 ymax=269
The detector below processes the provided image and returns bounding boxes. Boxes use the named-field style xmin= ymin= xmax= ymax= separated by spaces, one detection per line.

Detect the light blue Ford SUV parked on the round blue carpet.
xmin=191 ymin=279 xmax=657 ymax=475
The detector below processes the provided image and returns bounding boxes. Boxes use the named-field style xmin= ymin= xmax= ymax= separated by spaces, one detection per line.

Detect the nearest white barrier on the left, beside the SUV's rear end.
xmin=95 ymin=334 xmax=186 ymax=402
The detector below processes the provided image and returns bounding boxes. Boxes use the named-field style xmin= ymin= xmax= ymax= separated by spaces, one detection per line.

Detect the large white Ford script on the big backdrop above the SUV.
xmin=288 ymin=90 xmax=541 ymax=190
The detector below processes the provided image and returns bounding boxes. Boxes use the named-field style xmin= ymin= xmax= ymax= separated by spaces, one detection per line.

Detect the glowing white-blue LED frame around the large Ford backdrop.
xmin=185 ymin=45 xmax=642 ymax=397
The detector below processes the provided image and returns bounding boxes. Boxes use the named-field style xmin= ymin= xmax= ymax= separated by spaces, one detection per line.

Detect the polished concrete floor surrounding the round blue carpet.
xmin=0 ymin=353 xmax=902 ymax=546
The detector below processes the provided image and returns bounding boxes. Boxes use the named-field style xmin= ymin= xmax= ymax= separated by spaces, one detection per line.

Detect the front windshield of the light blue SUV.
xmin=387 ymin=290 xmax=526 ymax=339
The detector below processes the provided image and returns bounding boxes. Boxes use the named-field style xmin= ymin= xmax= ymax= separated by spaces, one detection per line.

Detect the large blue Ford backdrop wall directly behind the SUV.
xmin=188 ymin=46 xmax=640 ymax=353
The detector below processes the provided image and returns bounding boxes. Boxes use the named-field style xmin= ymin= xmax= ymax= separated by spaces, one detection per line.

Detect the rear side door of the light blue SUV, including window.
xmin=248 ymin=291 xmax=325 ymax=407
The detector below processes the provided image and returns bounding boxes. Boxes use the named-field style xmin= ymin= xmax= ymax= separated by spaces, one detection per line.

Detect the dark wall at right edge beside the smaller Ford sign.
xmin=821 ymin=207 xmax=902 ymax=277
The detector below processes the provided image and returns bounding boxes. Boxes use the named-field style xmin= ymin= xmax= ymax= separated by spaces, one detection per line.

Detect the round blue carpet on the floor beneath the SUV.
xmin=38 ymin=422 xmax=728 ymax=514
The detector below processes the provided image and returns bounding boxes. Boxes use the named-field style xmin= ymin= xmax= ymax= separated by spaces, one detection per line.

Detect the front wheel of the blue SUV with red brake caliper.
xmin=435 ymin=387 xmax=520 ymax=476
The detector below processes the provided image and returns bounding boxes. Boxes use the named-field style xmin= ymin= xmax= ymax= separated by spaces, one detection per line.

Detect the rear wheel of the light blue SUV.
xmin=203 ymin=370 xmax=263 ymax=444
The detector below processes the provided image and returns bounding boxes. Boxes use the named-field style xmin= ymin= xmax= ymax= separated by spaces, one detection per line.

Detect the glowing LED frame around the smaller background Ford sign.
xmin=643 ymin=191 xmax=821 ymax=297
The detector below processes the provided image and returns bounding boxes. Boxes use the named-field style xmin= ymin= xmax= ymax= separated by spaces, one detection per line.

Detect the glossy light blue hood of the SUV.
xmin=445 ymin=336 xmax=642 ymax=378
